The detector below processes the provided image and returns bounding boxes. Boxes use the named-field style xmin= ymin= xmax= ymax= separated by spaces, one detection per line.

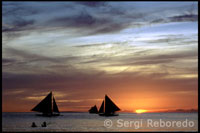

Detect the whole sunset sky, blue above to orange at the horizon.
xmin=2 ymin=1 xmax=198 ymax=112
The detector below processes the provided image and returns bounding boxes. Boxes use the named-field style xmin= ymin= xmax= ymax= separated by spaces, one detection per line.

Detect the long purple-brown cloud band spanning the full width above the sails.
xmin=2 ymin=67 xmax=197 ymax=95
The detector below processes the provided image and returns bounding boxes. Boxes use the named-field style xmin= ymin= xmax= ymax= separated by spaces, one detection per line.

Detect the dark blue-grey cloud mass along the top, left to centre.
xmin=2 ymin=2 xmax=141 ymax=35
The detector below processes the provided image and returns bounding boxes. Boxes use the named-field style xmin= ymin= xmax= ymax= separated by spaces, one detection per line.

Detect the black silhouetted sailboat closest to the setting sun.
xmin=99 ymin=95 xmax=120 ymax=116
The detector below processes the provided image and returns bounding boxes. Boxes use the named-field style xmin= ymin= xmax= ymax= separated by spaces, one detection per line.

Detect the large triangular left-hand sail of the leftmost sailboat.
xmin=31 ymin=92 xmax=52 ymax=114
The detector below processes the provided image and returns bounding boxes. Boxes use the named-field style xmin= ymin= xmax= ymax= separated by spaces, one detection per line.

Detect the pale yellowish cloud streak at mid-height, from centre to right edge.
xmin=76 ymin=44 xmax=198 ymax=67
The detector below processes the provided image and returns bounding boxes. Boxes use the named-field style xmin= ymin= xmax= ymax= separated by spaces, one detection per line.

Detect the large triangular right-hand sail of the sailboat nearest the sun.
xmin=105 ymin=95 xmax=120 ymax=114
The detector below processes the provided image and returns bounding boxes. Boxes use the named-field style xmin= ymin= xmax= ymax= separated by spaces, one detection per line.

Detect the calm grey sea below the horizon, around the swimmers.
xmin=2 ymin=112 xmax=198 ymax=132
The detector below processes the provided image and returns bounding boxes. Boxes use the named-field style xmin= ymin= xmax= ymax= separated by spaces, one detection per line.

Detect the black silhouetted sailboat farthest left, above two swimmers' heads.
xmin=31 ymin=92 xmax=60 ymax=116
